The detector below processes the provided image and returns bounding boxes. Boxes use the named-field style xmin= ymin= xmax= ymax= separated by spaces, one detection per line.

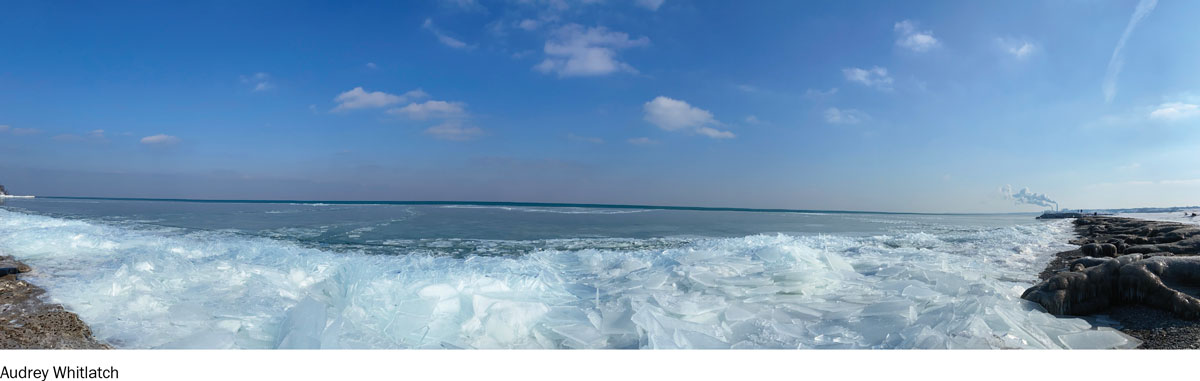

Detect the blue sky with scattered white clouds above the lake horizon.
xmin=0 ymin=0 xmax=1200 ymax=212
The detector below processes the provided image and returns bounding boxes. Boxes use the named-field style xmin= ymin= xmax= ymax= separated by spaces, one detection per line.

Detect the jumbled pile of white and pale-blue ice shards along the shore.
xmin=0 ymin=210 xmax=1136 ymax=349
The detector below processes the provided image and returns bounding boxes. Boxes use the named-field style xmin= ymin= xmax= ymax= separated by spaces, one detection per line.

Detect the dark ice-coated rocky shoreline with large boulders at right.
xmin=1021 ymin=217 xmax=1200 ymax=349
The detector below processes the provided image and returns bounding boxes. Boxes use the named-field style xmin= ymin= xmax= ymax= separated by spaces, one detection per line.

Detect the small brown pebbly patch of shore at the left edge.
xmin=0 ymin=255 xmax=110 ymax=349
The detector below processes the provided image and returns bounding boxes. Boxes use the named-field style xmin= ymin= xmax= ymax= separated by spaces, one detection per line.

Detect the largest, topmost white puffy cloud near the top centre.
xmin=534 ymin=24 xmax=650 ymax=77
